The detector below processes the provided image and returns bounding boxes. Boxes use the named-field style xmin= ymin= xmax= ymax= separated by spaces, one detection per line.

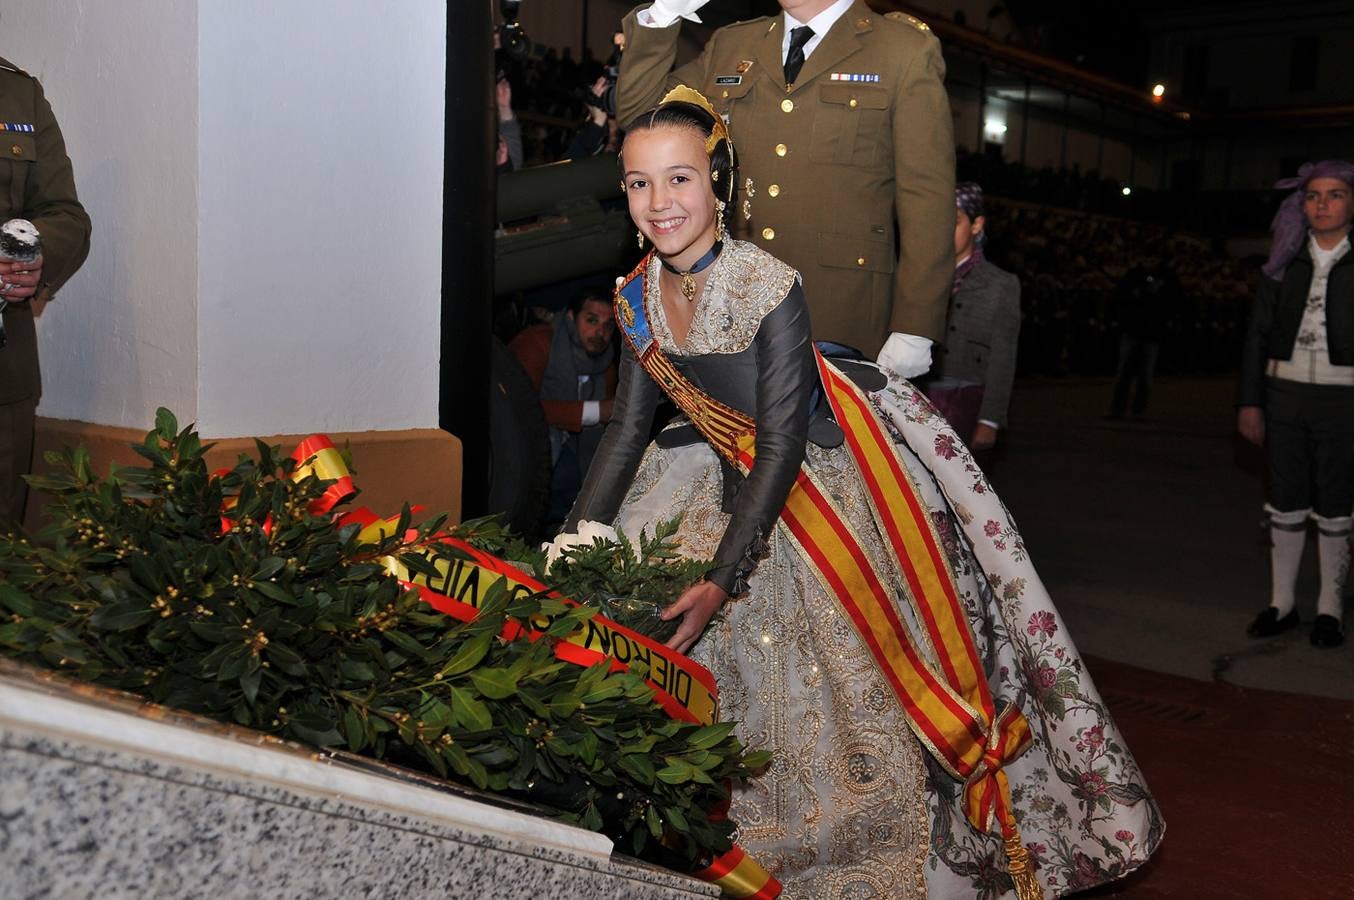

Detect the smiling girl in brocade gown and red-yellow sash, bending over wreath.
xmin=565 ymin=88 xmax=1163 ymax=899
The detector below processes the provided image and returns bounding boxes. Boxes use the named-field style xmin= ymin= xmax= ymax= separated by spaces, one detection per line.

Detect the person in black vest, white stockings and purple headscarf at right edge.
xmin=1236 ymin=160 xmax=1354 ymax=647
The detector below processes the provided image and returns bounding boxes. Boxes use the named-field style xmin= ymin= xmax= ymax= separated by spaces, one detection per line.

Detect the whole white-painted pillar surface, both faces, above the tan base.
xmin=0 ymin=0 xmax=445 ymax=436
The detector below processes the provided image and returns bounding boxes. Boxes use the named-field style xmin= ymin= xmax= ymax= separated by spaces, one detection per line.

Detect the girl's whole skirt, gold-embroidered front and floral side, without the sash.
xmin=616 ymin=368 xmax=1163 ymax=900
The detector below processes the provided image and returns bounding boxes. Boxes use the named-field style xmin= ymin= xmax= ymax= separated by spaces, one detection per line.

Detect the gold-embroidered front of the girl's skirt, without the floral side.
xmin=617 ymin=444 xmax=930 ymax=900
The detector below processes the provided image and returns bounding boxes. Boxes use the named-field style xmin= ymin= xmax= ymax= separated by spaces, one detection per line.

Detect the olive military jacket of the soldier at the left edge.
xmin=0 ymin=60 xmax=89 ymax=403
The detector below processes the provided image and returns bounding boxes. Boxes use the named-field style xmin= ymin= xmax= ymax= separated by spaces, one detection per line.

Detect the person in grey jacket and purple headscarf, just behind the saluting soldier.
xmin=923 ymin=181 xmax=1020 ymax=449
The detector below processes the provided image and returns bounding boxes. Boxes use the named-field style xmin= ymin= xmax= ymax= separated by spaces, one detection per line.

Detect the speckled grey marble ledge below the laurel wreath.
xmin=0 ymin=663 xmax=719 ymax=900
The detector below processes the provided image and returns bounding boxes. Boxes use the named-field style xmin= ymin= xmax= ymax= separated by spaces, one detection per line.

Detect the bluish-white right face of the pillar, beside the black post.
xmin=196 ymin=0 xmax=444 ymax=434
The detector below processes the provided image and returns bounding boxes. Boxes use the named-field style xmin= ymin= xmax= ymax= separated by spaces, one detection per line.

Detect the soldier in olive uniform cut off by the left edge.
xmin=0 ymin=60 xmax=89 ymax=526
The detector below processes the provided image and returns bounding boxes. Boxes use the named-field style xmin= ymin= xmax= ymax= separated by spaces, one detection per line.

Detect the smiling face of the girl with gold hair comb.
xmin=621 ymin=126 xmax=715 ymax=269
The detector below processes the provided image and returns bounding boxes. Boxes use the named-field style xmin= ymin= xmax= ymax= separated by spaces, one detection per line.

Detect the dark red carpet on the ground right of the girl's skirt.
xmin=1080 ymin=659 xmax=1354 ymax=900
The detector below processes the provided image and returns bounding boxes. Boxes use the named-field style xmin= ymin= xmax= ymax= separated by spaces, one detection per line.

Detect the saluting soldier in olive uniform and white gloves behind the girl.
xmin=617 ymin=0 xmax=955 ymax=368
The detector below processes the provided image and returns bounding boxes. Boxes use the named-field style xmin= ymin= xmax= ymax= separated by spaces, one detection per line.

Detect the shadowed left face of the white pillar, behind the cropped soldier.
xmin=0 ymin=0 xmax=198 ymax=428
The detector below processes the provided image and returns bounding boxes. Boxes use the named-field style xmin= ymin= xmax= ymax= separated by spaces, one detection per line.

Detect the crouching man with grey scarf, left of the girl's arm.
xmin=508 ymin=294 xmax=617 ymax=525
